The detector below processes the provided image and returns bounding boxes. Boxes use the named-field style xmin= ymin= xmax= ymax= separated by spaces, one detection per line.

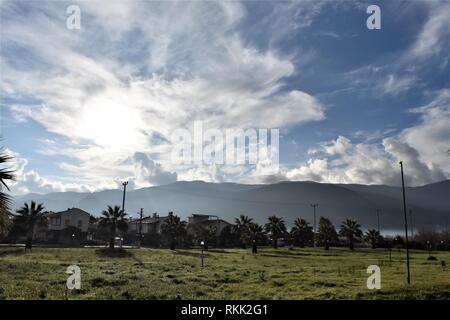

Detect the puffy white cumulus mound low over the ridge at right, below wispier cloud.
xmin=278 ymin=137 xmax=446 ymax=186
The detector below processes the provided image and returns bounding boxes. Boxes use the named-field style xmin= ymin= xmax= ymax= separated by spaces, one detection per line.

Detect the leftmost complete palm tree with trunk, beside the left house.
xmin=14 ymin=201 xmax=47 ymax=249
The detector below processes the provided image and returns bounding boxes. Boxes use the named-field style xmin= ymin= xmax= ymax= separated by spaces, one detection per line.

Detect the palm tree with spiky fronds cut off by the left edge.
xmin=0 ymin=152 xmax=14 ymax=239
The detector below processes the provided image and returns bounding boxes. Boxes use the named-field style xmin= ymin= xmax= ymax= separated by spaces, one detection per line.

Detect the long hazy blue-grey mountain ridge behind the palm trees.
xmin=14 ymin=180 xmax=450 ymax=229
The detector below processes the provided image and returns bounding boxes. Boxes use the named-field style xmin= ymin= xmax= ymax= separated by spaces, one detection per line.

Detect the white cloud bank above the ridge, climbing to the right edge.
xmin=260 ymin=89 xmax=450 ymax=186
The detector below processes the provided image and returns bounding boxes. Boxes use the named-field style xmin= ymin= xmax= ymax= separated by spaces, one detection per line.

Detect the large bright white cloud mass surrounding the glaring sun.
xmin=0 ymin=2 xmax=324 ymax=190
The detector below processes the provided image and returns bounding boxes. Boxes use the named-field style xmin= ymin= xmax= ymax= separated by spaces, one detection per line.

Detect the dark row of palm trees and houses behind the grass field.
xmin=2 ymin=207 xmax=450 ymax=250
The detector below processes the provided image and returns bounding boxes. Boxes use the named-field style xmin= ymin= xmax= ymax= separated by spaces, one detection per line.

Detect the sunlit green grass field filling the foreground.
xmin=0 ymin=247 xmax=450 ymax=299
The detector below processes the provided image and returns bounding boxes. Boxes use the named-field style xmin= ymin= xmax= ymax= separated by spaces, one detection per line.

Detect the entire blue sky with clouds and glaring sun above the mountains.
xmin=0 ymin=0 xmax=450 ymax=194
